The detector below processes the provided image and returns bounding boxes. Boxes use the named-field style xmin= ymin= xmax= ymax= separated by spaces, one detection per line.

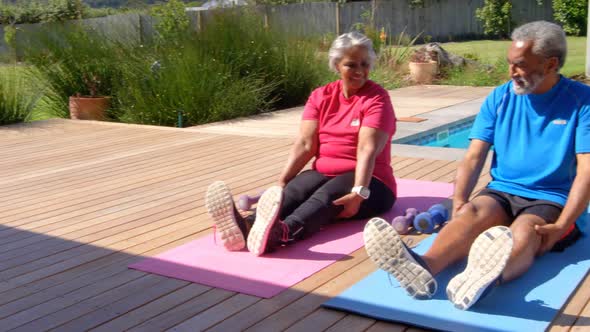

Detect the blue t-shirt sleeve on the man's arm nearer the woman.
xmin=469 ymin=89 xmax=505 ymax=144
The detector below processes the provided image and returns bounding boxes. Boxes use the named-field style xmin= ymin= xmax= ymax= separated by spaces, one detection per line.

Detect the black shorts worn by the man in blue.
xmin=477 ymin=188 xmax=582 ymax=251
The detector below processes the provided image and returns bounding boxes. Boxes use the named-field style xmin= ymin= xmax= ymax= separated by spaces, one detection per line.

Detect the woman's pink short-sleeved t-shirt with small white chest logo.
xmin=303 ymin=80 xmax=396 ymax=194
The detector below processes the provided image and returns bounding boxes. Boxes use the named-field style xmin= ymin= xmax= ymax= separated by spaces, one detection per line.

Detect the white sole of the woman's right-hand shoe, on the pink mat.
xmin=247 ymin=186 xmax=283 ymax=256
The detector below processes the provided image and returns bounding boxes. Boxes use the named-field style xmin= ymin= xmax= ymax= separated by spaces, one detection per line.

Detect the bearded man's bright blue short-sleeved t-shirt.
xmin=469 ymin=77 xmax=590 ymax=206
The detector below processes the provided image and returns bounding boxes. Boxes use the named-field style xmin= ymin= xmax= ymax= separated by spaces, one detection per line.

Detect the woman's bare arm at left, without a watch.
xmin=279 ymin=120 xmax=318 ymax=187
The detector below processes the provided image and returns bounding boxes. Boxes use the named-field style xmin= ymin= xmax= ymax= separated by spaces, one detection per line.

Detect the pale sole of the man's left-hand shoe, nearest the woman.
xmin=363 ymin=218 xmax=437 ymax=299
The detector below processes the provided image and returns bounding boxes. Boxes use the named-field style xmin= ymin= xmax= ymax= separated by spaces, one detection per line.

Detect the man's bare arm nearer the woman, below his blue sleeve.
xmin=453 ymin=139 xmax=490 ymax=215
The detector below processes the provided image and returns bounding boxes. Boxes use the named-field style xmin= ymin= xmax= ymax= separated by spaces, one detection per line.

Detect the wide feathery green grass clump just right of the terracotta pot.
xmin=117 ymin=43 xmax=278 ymax=126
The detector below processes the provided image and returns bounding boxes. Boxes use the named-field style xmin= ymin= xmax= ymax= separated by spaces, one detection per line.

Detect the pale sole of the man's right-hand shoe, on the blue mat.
xmin=447 ymin=226 xmax=513 ymax=310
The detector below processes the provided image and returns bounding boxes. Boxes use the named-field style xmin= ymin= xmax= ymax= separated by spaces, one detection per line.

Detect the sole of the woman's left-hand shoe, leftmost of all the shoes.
xmin=205 ymin=181 xmax=246 ymax=251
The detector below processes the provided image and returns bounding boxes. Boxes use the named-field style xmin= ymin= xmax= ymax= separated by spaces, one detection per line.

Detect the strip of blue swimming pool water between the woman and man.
xmin=400 ymin=118 xmax=474 ymax=149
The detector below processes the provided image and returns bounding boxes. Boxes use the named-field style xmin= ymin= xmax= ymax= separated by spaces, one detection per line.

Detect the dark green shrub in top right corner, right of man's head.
xmin=553 ymin=0 xmax=588 ymax=36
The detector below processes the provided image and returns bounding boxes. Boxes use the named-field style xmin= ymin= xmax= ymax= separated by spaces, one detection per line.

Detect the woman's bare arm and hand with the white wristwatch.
xmin=333 ymin=127 xmax=389 ymax=218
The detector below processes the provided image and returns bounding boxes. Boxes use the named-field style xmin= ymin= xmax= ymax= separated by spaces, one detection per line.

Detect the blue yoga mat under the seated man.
xmin=323 ymin=209 xmax=590 ymax=332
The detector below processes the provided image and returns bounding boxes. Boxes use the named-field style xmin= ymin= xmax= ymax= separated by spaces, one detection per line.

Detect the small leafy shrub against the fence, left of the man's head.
xmin=475 ymin=0 xmax=514 ymax=37
